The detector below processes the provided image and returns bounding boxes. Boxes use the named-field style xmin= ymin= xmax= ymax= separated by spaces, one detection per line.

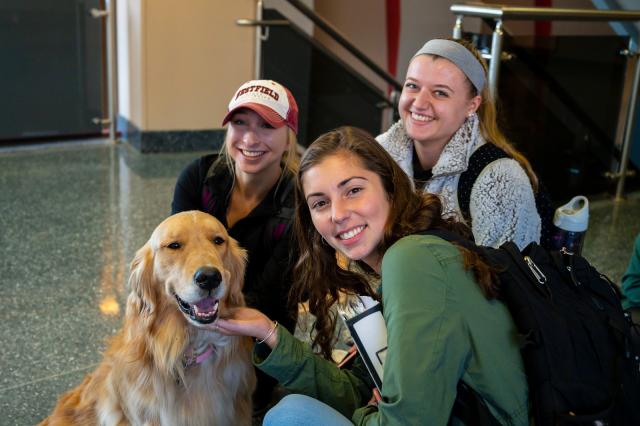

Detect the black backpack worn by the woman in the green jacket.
xmin=425 ymin=230 xmax=640 ymax=426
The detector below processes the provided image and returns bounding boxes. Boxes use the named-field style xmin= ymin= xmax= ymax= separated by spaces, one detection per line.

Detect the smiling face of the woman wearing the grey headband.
xmin=398 ymin=55 xmax=482 ymax=147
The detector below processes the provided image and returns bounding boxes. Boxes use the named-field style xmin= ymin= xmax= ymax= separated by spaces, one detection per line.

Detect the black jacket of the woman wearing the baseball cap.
xmin=171 ymin=154 xmax=297 ymax=333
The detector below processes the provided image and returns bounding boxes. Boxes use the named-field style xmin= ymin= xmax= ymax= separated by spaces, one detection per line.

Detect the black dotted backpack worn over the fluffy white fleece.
xmin=458 ymin=143 xmax=555 ymax=249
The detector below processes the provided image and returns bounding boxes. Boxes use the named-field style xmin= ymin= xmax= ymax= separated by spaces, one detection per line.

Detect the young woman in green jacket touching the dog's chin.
xmin=214 ymin=127 xmax=528 ymax=425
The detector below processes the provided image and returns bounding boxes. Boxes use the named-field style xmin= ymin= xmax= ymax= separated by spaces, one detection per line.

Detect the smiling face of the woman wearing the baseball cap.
xmin=226 ymin=108 xmax=289 ymax=175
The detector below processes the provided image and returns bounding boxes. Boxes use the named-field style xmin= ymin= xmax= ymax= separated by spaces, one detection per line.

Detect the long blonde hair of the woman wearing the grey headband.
xmin=429 ymin=38 xmax=538 ymax=192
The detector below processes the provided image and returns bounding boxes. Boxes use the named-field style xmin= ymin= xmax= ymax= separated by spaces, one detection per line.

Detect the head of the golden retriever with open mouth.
xmin=129 ymin=211 xmax=246 ymax=326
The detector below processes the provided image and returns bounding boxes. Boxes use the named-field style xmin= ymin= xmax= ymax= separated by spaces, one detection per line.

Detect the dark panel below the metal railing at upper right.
xmin=468 ymin=35 xmax=628 ymax=201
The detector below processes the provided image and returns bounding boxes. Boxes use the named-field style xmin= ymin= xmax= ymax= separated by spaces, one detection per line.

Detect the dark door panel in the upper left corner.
xmin=0 ymin=0 xmax=103 ymax=144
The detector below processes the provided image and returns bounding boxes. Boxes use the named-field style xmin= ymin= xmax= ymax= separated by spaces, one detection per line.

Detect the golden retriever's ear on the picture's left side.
xmin=127 ymin=243 xmax=158 ymax=324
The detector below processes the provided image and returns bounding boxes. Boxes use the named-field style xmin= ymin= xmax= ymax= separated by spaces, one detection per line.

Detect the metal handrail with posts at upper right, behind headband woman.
xmin=449 ymin=3 xmax=640 ymax=201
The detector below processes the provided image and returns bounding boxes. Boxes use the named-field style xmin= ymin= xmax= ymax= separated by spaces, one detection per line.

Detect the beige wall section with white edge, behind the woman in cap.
xmin=117 ymin=0 xmax=255 ymax=131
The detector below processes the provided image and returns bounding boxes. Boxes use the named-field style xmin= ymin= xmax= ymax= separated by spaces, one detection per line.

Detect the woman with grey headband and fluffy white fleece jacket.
xmin=376 ymin=39 xmax=546 ymax=248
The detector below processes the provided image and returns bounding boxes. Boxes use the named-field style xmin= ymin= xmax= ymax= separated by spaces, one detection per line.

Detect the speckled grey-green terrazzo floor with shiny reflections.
xmin=0 ymin=140 xmax=640 ymax=425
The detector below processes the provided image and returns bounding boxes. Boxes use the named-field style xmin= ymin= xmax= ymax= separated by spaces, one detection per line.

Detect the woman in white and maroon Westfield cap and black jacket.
xmin=171 ymin=80 xmax=299 ymax=410
